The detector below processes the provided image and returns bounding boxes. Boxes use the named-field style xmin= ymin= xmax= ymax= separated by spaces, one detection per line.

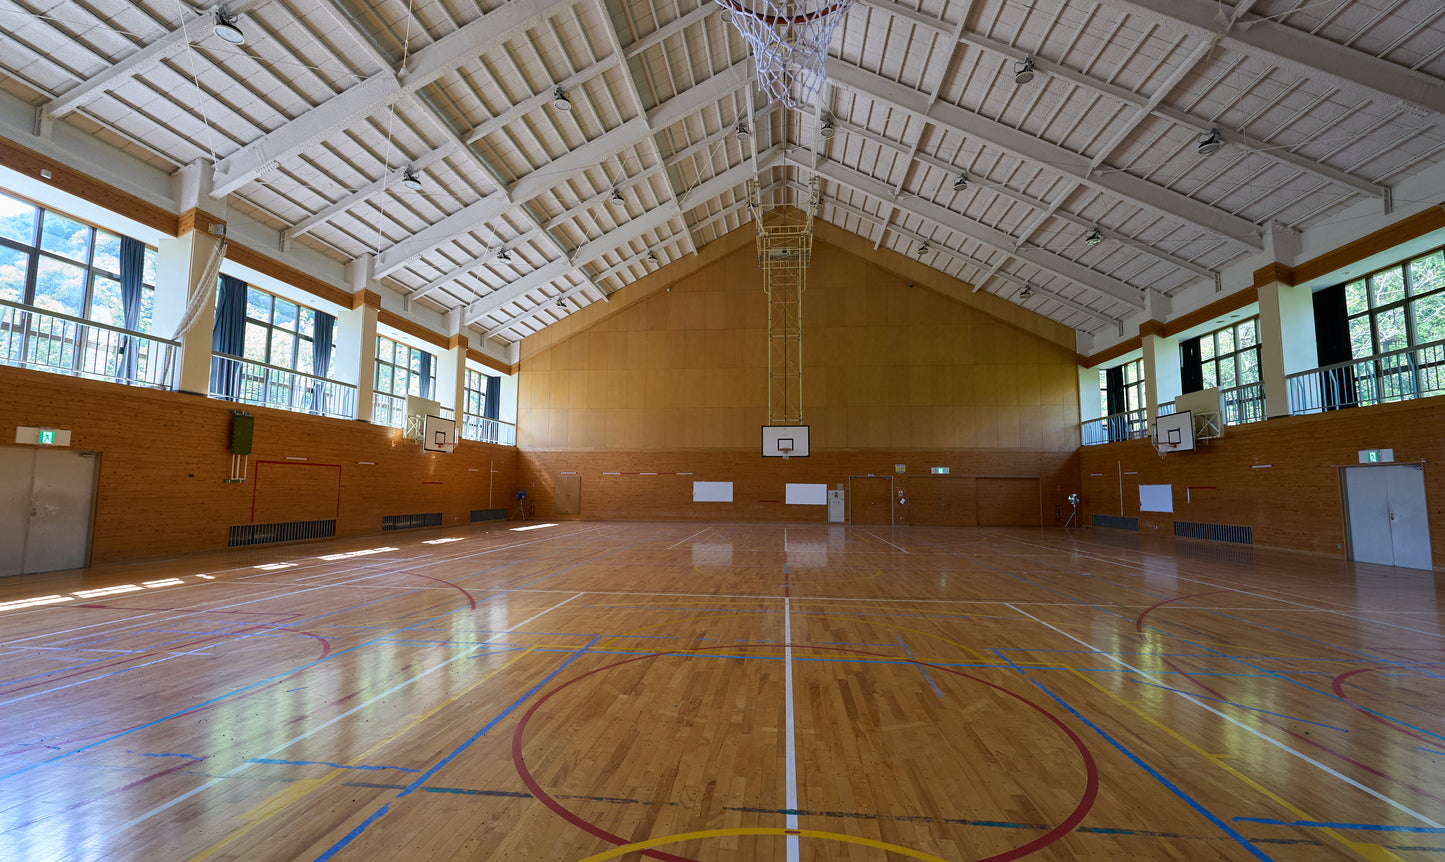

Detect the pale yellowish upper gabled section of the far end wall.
xmin=517 ymin=225 xmax=1078 ymax=450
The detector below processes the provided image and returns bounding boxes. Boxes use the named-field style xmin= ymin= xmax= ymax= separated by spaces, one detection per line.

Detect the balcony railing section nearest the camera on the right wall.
xmin=1285 ymin=339 xmax=1445 ymax=416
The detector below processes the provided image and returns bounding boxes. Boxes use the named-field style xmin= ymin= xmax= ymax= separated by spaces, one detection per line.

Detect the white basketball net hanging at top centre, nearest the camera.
xmin=715 ymin=0 xmax=853 ymax=108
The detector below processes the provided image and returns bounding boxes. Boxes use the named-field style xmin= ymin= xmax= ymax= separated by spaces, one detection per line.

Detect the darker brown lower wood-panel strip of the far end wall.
xmin=520 ymin=448 xmax=1079 ymax=526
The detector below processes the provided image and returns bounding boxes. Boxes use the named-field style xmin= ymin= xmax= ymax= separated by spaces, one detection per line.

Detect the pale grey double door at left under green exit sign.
xmin=0 ymin=446 xmax=97 ymax=576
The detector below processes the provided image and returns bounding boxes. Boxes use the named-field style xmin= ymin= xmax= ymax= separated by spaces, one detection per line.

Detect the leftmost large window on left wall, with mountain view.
xmin=0 ymin=193 xmax=160 ymax=383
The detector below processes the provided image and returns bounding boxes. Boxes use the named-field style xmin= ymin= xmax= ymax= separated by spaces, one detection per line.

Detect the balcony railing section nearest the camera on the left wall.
xmin=0 ymin=299 xmax=181 ymax=388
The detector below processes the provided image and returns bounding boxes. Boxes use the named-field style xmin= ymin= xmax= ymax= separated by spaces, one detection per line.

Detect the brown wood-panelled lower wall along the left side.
xmin=0 ymin=367 xmax=519 ymax=565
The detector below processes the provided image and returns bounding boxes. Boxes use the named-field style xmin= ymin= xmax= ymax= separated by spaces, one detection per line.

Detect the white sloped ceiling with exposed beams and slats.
xmin=0 ymin=0 xmax=1445 ymax=342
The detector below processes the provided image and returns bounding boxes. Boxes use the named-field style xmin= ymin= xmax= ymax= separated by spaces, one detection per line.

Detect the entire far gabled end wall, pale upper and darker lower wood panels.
xmin=517 ymin=230 xmax=1078 ymax=524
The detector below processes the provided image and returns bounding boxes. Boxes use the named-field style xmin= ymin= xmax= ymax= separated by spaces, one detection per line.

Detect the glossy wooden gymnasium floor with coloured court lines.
xmin=0 ymin=523 xmax=1445 ymax=862
